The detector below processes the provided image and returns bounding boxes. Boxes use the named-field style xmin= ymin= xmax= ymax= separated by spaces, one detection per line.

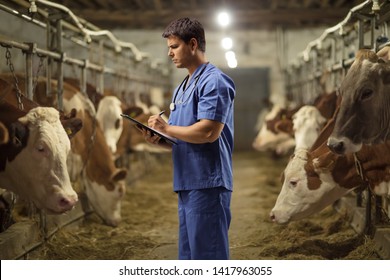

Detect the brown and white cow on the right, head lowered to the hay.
xmin=270 ymin=112 xmax=390 ymax=224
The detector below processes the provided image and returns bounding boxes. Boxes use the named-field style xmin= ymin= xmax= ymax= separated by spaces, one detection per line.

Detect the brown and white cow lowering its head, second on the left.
xmin=63 ymin=83 xmax=127 ymax=226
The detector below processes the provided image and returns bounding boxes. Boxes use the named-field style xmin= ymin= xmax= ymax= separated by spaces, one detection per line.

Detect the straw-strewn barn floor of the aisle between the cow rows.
xmin=28 ymin=152 xmax=380 ymax=260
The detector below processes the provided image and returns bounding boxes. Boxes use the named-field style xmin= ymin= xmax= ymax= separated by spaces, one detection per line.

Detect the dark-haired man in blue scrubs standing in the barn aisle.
xmin=143 ymin=18 xmax=235 ymax=260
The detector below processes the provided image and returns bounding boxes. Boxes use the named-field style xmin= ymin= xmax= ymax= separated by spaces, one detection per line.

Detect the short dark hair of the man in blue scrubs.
xmin=162 ymin=18 xmax=206 ymax=52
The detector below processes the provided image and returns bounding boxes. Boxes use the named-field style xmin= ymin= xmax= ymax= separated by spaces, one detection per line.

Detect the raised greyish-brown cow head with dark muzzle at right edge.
xmin=328 ymin=50 xmax=390 ymax=154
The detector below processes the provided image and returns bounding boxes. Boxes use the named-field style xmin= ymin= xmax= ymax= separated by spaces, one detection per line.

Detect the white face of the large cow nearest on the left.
xmin=2 ymin=107 xmax=77 ymax=214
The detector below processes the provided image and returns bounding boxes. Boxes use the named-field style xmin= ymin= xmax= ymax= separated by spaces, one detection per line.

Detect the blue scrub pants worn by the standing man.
xmin=178 ymin=187 xmax=232 ymax=260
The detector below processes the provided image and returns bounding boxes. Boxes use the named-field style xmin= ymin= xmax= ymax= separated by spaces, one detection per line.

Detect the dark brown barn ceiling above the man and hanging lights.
xmin=1 ymin=0 xmax=372 ymax=30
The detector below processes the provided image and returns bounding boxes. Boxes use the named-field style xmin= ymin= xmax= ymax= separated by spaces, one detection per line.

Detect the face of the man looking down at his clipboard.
xmin=167 ymin=36 xmax=192 ymax=68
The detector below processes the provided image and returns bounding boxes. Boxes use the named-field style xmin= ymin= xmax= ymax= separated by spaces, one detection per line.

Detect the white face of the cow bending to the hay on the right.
xmin=270 ymin=149 xmax=348 ymax=224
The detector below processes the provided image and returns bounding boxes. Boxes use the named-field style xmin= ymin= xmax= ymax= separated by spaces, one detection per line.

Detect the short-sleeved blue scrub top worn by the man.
xmin=168 ymin=63 xmax=235 ymax=191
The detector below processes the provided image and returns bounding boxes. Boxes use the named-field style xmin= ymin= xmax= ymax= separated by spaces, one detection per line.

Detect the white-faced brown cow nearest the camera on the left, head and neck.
xmin=0 ymin=79 xmax=77 ymax=214
